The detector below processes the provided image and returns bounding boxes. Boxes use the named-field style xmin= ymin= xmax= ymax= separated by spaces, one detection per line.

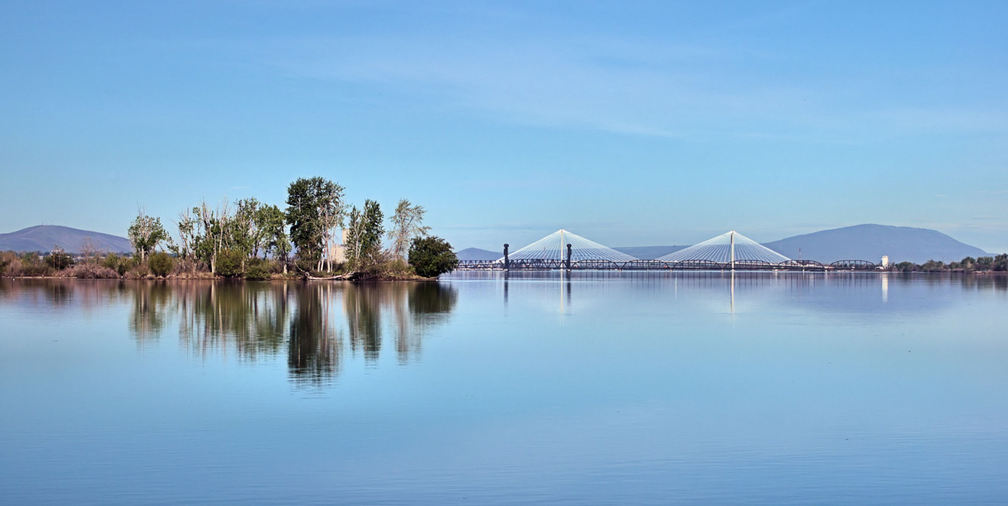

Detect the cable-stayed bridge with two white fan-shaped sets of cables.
xmin=458 ymin=229 xmax=879 ymax=271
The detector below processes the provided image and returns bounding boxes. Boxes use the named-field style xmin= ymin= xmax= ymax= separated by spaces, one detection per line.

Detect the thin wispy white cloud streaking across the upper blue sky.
xmin=224 ymin=17 xmax=1008 ymax=143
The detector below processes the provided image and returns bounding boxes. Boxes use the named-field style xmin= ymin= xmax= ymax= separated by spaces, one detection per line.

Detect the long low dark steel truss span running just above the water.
xmin=456 ymin=259 xmax=881 ymax=272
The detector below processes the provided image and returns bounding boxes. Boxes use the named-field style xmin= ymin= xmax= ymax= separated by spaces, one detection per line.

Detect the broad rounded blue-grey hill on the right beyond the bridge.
xmin=763 ymin=225 xmax=987 ymax=263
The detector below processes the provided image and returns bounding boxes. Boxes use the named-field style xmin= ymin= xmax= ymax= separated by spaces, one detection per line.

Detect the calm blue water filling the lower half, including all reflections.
xmin=0 ymin=273 xmax=1008 ymax=504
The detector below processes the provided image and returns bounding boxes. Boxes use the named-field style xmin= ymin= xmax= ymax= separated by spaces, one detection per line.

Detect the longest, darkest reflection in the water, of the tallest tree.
xmin=287 ymin=283 xmax=343 ymax=384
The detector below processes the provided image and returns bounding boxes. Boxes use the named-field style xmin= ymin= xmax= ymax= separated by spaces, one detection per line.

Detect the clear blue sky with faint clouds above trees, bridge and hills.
xmin=0 ymin=0 xmax=1008 ymax=252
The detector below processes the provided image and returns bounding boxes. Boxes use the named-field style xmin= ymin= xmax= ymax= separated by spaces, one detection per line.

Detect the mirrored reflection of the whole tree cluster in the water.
xmin=116 ymin=281 xmax=458 ymax=385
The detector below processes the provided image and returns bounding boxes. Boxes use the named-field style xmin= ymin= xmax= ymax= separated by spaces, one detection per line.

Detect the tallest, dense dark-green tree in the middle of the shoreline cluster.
xmin=287 ymin=177 xmax=345 ymax=270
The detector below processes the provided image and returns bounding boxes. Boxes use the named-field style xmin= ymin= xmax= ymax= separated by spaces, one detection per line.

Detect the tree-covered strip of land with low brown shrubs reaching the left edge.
xmin=0 ymin=177 xmax=458 ymax=279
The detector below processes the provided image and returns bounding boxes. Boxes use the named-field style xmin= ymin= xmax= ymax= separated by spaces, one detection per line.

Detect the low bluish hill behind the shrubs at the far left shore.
xmin=0 ymin=225 xmax=133 ymax=254
